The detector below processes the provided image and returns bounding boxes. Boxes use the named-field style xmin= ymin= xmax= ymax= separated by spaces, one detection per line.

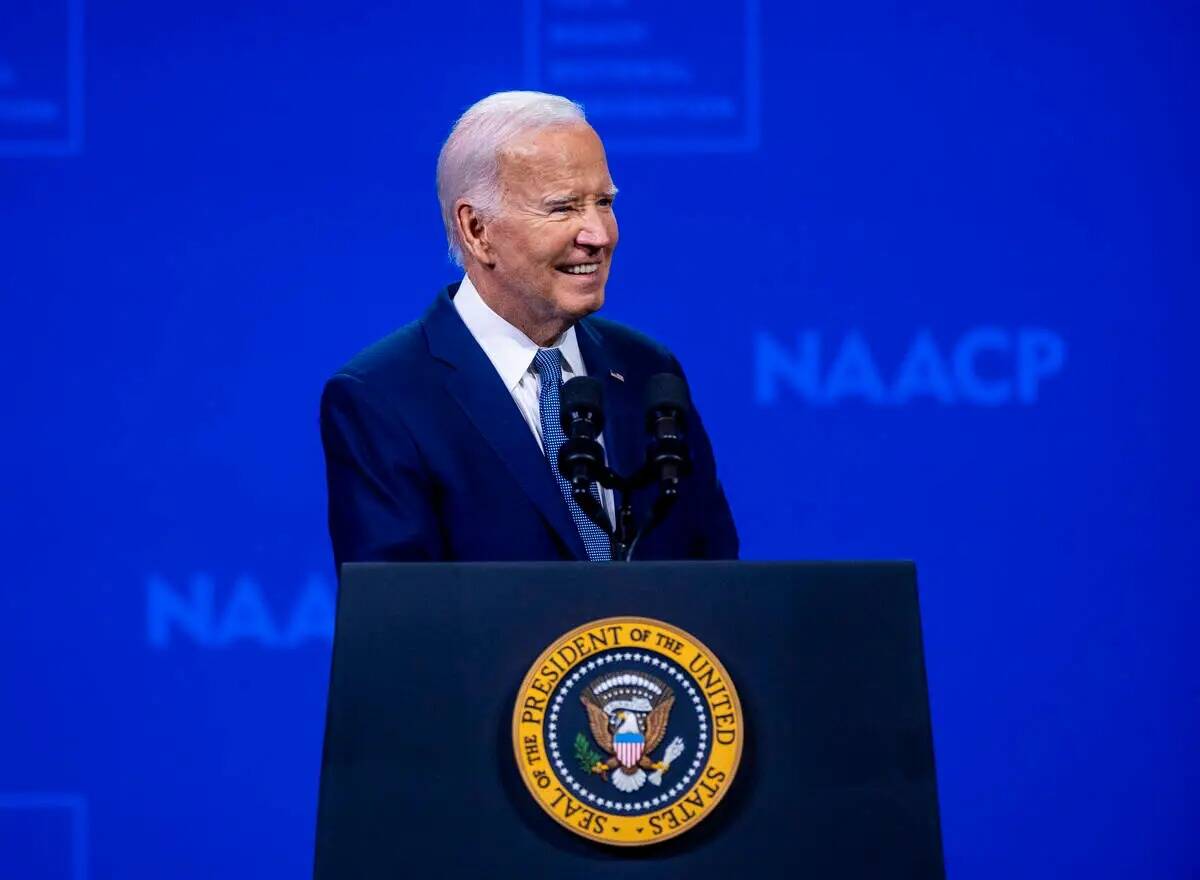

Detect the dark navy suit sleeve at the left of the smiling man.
xmin=320 ymin=373 xmax=445 ymax=573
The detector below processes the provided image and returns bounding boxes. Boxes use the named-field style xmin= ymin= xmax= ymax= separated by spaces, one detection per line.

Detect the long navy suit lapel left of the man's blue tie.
xmin=422 ymin=285 xmax=587 ymax=559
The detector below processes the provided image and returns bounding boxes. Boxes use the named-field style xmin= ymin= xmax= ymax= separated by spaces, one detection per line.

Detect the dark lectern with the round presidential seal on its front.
xmin=314 ymin=562 xmax=944 ymax=880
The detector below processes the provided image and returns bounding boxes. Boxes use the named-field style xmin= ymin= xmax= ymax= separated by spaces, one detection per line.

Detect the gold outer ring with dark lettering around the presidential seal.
xmin=512 ymin=616 xmax=745 ymax=846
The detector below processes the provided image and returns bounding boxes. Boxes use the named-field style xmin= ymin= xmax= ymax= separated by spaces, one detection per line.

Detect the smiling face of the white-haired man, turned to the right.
xmin=487 ymin=124 xmax=617 ymax=323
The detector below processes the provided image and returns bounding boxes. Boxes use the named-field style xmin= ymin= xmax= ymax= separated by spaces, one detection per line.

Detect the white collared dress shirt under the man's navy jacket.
xmin=452 ymin=275 xmax=616 ymax=525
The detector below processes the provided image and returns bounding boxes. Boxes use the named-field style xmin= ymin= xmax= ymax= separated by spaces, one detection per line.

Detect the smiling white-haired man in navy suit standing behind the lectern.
xmin=322 ymin=91 xmax=738 ymax=565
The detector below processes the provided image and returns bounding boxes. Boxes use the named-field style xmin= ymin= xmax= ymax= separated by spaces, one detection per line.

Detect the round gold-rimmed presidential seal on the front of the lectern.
xmin=512 ymin=617 xmax=744 ymax=846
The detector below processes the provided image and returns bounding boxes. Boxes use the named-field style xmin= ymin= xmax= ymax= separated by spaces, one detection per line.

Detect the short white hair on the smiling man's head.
xmin=438 ymin=91 xmax=587 ymax=265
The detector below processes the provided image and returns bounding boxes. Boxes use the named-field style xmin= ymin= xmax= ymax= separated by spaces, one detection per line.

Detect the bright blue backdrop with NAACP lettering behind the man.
xmin=0 ymin=0 xmax=1200 ymax=880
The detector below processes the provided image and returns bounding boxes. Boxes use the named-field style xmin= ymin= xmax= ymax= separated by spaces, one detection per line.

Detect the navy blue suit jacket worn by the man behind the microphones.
xmin=320 ymin=285 xmax=738 ymax=567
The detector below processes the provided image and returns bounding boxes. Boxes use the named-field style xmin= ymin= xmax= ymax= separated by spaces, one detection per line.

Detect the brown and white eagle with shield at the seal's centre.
xmin=580 ymin=672 xmax=683 ymax=792
